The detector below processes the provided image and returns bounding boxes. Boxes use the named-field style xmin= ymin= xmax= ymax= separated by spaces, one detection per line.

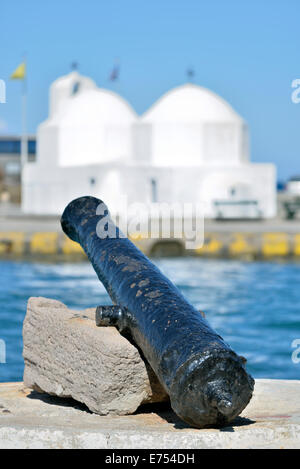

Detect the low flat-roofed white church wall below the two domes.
xmin=23 ymin=159 xmax=276 ymax=217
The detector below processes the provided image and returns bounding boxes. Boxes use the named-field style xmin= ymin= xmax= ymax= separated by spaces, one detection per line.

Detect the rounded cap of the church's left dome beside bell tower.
xmin=58 ymin=88 xmax=137 ymax=127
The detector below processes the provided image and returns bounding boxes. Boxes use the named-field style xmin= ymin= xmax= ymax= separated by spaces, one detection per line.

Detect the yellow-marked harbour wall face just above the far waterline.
xmin=0 ymin=229 xmax=300 ymax=260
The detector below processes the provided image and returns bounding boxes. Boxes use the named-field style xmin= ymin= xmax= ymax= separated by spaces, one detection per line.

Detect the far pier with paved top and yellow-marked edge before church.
xmin=0 ymin=205 xmax=300 ymax=260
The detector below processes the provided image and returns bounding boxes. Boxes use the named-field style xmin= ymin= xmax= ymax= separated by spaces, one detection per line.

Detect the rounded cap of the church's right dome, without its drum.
xmin=142 ymin=84 xmax=242 ymax=123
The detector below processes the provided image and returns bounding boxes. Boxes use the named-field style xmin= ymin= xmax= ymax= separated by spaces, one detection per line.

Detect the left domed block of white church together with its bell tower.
xmin=38 ymin=71 xmax=137 ymax=167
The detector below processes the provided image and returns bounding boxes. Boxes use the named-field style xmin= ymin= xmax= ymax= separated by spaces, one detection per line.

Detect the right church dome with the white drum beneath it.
xmin=135 ymin=84 xmax=248 ymax=167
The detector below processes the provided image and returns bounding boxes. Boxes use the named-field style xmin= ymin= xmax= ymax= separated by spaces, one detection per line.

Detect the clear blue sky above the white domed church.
xmin=0 ymin=0 xmax=300 ymax=179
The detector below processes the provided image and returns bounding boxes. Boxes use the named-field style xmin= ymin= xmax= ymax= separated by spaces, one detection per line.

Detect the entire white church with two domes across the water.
xmin=22 ymin=71 xmax=276 ymax=219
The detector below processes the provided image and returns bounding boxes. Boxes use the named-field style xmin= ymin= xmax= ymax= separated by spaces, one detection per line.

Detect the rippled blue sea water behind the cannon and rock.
xmin=0 ymin=257 xmax=300 ymax=382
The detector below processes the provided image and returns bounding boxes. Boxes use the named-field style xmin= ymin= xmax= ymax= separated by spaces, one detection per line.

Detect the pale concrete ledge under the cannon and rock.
xmin=0 ymin=380 xmax=300 ymax=449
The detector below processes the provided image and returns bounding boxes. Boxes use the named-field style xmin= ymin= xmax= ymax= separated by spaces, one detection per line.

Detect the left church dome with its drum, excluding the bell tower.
xmin=51 ymin=88 xmax=136 ymax=166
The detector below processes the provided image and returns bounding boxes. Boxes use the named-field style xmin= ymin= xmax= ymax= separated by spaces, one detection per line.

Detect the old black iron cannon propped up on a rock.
xmin=61 ymin=196 xmax=254 ymax=428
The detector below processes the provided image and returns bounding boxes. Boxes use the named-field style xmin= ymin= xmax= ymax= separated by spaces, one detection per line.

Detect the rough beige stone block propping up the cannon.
xmin=23 ymin=298 xmax=167 ymax=415
